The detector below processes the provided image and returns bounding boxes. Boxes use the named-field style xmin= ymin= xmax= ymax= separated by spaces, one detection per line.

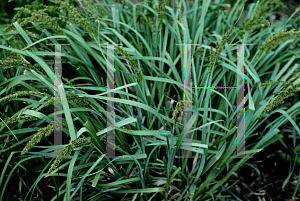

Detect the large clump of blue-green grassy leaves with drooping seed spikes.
xmin=0 ymin=0 xmax=300 ymax=200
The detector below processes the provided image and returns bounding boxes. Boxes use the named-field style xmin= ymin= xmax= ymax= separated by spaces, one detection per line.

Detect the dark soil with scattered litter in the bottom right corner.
xmin=228 ymin=136 xmax=300 ymax=201
